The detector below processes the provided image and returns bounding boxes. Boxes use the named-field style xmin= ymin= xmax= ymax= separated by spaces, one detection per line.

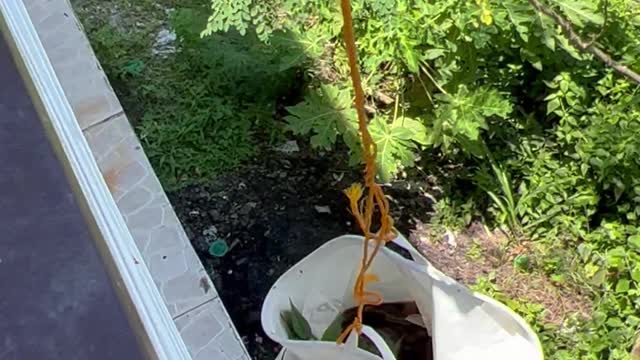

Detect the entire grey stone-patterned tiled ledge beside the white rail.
xmin=24 ymin=0 xmax=249 ymax=360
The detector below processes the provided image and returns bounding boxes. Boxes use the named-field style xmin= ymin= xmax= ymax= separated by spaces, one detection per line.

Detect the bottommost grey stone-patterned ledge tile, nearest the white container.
xmin=176 ymin=299 xmax=249 ymax=360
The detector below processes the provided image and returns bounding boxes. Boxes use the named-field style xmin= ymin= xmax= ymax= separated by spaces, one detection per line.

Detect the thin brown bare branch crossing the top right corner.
xmin=529 ymin=0 xmax=640 ymax=84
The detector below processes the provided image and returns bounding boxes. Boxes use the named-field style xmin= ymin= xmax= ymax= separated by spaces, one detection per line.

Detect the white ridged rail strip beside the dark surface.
xmin=0 ymin=0 xmax=192 ymax=360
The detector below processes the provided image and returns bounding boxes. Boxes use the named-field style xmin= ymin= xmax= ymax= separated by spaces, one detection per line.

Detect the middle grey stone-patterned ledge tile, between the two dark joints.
xmin=85 ymin=116 xmax=218 ymax=317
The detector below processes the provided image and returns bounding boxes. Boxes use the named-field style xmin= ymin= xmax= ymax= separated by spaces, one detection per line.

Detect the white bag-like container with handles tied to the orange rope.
xmin=262 ymin=235 xmax=543 ymax=360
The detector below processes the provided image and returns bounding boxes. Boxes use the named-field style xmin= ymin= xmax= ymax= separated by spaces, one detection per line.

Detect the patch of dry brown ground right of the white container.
xmin=411 ymin=222 xmax=592 ymax=325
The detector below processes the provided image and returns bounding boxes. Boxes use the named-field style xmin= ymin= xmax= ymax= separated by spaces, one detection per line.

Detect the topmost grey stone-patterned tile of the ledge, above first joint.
xmin=24 ymin=0 xmax=122 ymax=129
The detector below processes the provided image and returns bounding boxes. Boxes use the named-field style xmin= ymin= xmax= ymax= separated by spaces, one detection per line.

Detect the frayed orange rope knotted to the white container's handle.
xmin=337 ymin=0 xmax=396 ymax=343
